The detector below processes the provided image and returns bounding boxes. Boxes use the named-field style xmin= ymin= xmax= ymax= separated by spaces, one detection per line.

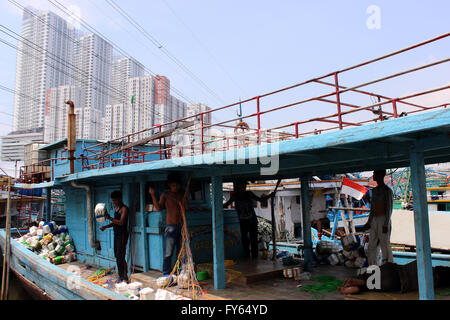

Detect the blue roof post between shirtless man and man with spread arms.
xmin=211 ymin=176 xmax=225 ymax=290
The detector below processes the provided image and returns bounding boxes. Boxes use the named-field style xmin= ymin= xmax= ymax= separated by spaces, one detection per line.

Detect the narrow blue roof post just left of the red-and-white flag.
xmin=300 ymin=176 xmax=313 ymax=271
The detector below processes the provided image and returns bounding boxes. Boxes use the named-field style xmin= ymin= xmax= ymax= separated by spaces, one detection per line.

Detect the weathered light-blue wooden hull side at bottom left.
xmin=0 ymin=229 xmax=127 ymax=300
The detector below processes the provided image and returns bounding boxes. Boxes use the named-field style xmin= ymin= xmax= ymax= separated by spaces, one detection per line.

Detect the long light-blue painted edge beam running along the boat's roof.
xmin=55 ymin=109 xmax=450 ymax=183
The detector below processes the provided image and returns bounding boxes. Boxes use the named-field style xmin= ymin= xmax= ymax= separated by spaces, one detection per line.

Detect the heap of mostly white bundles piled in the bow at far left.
xmin=17 ymin=221 xmax=76 ymax=265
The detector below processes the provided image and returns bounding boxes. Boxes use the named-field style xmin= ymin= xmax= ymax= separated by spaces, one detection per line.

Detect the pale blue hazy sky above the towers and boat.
xmin=0 ymin=0 xmax=450 ymax=135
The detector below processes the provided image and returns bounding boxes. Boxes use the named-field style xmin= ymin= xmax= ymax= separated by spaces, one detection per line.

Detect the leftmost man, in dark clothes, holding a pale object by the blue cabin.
xmin=100 ymin=191 xmax=128 ymax=282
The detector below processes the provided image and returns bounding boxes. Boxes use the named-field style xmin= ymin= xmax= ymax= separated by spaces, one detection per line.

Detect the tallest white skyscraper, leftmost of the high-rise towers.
xmin=13 ymin=8 xmax=74 ymax=131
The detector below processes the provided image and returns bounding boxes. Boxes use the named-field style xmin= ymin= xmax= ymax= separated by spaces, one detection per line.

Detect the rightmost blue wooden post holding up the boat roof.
xmin=411 ymin=147 xmax=434 ymax=300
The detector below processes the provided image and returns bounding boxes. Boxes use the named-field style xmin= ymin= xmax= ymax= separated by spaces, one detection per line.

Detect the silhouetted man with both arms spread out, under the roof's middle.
xmin=223 ymin=181 xmax=269 ymax=259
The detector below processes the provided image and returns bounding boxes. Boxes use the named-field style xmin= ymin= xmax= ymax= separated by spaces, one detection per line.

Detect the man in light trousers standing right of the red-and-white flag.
xmin=364 ymin=170 xmax=393 ymax=265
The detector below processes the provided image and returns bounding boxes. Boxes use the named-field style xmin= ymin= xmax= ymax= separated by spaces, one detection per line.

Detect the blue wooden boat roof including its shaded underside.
xmin=51 ymin=109 xmax=450 ymax=185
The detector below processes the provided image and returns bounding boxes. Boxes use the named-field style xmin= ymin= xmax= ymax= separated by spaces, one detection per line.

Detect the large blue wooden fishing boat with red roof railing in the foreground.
xmin=0 ymin=35 xmax=450 ymax=299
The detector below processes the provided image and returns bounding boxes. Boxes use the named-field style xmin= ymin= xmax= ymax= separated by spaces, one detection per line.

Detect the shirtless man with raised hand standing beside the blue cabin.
xmin=149 ymin=174 xmax=189 ymax=276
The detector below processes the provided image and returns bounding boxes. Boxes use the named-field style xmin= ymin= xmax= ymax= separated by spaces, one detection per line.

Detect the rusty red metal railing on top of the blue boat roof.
xmin=83 ymin=33 xmax=450 ymax=170
